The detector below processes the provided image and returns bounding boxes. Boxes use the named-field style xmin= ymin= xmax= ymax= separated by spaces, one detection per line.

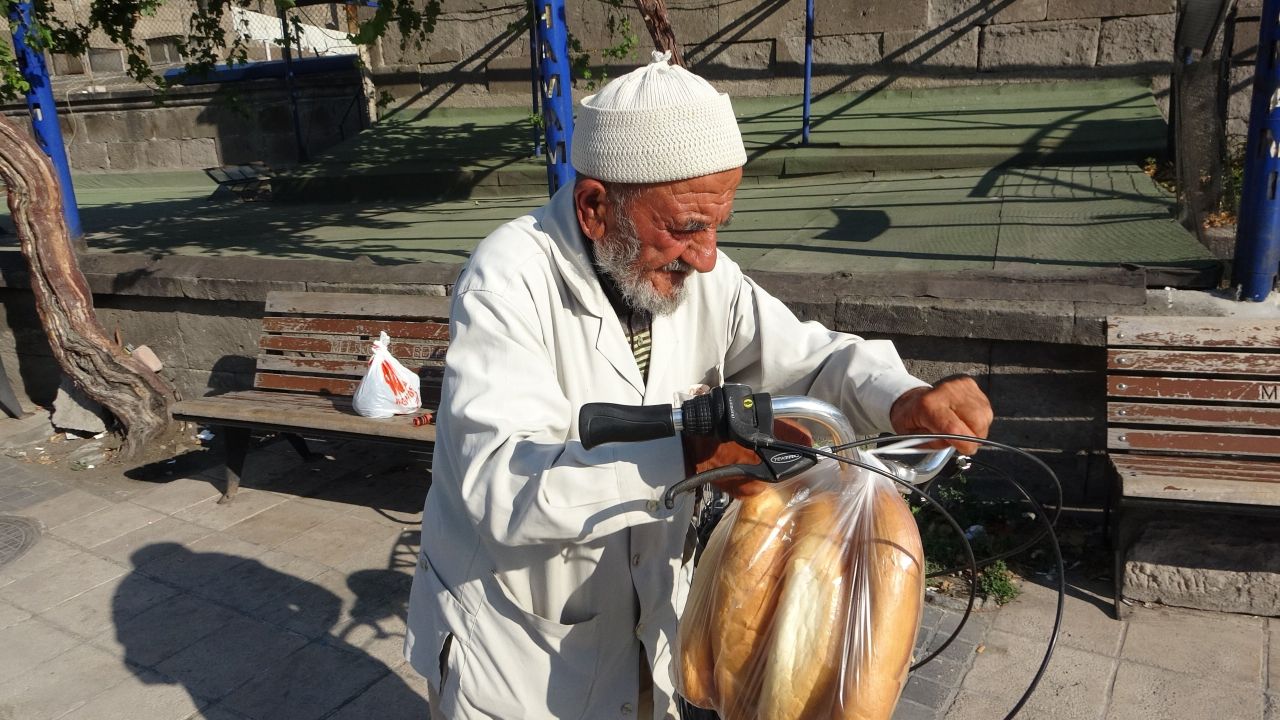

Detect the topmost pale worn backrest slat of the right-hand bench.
xmin=1107 ymin=315 xmax=1280 ymax=350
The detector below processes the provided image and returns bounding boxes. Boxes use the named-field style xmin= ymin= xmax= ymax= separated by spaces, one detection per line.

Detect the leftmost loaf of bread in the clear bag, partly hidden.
xmin=676 ymin=512 xmax=730 ymax=710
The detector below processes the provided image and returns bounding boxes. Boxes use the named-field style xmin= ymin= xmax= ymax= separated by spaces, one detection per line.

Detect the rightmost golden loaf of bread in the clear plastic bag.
xmin=832 ymin=483 xmax=924 ymax=720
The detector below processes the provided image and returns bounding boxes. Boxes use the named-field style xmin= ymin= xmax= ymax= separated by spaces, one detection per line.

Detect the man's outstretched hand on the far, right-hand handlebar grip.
xmin=890 ymin=375 xmax=993 ymax=455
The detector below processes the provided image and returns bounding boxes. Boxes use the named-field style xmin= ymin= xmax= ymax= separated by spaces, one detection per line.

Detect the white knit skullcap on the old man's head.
xmin=570 ymin=53 xmax=746 ymax=183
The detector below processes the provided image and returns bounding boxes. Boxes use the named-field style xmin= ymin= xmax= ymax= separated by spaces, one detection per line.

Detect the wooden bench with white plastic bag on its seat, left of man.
xmin=173 ymin=292 xmax=449 ymax=502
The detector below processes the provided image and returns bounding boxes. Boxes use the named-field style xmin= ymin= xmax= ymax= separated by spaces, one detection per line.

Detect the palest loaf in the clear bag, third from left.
xmin=759 ymin=492 xmax=849 ymax=720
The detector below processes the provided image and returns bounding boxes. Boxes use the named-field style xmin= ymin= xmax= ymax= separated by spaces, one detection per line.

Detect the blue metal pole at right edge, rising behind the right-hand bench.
xmin=1231 ymin=0 xmax=1280 ymax=302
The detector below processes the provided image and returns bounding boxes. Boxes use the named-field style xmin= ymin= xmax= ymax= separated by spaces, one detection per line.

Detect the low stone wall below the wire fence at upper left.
xmin=0 ymin=72 xmax=364 ymax=172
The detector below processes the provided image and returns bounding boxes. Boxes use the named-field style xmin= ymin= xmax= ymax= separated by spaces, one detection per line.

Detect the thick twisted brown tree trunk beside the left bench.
xmin=0 ymin=118 xmax=174 ymax=460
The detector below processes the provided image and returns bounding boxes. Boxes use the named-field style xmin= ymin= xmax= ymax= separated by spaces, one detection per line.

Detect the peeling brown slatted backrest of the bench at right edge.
xmin=1107 ymin=316 xmax=1280 ymax=461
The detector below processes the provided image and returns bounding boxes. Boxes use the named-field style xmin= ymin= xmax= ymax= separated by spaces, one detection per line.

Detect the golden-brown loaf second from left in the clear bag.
xmin=710 ymin=486 xmax=794 ymax=720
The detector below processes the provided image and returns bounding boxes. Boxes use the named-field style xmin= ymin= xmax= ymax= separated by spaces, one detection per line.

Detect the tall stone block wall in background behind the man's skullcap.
xmin=376 ymin=0 xmax=1175 ymax=105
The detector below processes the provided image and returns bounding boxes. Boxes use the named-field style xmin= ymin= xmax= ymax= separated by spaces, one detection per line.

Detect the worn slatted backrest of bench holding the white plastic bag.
xmin=253 ymin=292 xmax=449 ymax=407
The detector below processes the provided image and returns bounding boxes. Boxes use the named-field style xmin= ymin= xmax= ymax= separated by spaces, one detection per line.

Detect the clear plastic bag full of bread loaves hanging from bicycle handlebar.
xmin=675 ymin=452 xmax=924 ymax=720
